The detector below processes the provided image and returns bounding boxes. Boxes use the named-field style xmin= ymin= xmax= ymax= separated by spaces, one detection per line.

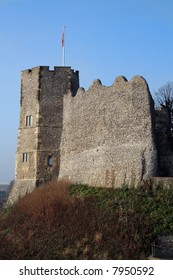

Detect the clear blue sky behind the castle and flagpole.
xmin=0 ymin=0 xmax=173 ymax=182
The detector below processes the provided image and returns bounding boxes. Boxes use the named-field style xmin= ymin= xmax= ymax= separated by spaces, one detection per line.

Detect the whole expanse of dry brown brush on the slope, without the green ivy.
xmin=0 ymin=181 xmax=154 ymax=260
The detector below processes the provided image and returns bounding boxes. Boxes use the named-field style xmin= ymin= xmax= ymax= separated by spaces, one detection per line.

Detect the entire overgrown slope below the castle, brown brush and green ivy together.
xmin=0 ymin=181 xmax=173 ymax=259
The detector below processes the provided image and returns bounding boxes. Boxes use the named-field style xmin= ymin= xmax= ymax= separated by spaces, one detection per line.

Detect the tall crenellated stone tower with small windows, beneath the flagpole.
xmin=9 ymin=66 xmax=79 ymax=201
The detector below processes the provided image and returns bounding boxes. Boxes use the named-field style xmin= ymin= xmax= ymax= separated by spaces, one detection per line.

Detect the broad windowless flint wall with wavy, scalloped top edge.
xmin=59 ymin=76 xmax=157 ymax=187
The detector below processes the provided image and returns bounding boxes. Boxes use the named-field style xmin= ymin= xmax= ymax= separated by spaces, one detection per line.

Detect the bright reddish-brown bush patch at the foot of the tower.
xmin=15 ymin=180 xmax=72 ymax=224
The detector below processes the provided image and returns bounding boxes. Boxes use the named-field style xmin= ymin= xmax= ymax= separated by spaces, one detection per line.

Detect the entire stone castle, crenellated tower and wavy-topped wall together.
xmin=8 ymin=66 xmax=173 ymax=203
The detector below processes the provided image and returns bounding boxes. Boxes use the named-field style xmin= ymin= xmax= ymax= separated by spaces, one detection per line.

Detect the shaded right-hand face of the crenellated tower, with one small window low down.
xmin=37 ymin=67 xmax=75 ymax=184
